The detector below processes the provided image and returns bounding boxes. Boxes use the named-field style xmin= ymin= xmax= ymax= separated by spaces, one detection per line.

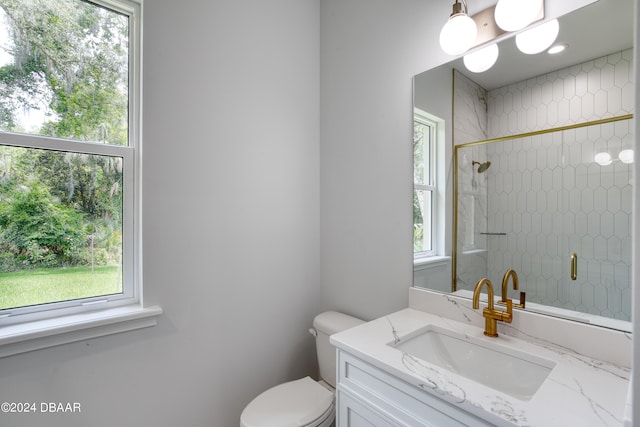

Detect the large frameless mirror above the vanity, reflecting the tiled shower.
xmin=414 ymin=0 xmax=634 ymax=331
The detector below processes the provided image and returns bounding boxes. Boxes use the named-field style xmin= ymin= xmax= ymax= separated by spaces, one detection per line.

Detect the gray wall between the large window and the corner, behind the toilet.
xmin=0 ymin=0 xmax=320 ymax=427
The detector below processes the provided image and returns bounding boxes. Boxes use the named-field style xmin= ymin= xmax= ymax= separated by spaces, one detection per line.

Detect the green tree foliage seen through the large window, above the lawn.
xmin=0 ymin=0 xmax=129 ymax=266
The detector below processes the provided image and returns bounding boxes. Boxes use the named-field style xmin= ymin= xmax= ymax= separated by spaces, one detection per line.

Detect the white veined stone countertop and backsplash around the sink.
xmin=331 ymin=293 xmax=631 ymax=427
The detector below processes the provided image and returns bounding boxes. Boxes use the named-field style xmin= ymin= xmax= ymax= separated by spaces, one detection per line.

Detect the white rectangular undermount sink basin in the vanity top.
xmin=389 ymin=325 xmax=555 ymax=400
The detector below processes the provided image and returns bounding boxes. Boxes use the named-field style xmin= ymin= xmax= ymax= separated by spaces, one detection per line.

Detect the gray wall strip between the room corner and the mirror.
xmin=320 ymin=0 xmax=451 ymax=319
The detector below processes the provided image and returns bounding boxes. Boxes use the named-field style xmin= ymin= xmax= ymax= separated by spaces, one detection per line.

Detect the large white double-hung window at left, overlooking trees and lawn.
xmin=0 ymin=0 xmax=140 ymax=324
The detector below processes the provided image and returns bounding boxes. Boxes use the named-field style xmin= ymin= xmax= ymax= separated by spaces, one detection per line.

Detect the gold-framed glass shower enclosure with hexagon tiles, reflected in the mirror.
xmin=452 ymin=115 xmax=633 ymax=327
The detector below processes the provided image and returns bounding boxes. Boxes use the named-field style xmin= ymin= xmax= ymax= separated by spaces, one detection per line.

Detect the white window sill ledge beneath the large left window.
xmin=0 ymin=305 xmax=162 ymax=358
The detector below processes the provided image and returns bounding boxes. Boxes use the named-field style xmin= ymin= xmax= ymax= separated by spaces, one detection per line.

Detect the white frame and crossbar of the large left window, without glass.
xmin=0 ymin=0 xmax=142 ymax=328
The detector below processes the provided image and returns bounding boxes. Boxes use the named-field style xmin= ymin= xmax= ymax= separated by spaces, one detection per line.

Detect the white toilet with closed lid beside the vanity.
xmin=240 ymin=311 xmax=364 ymax=427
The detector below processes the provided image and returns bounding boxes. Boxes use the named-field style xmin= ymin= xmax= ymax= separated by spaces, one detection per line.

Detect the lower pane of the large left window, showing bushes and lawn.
xmin=0 ymin=146 xmax=123 ymax=309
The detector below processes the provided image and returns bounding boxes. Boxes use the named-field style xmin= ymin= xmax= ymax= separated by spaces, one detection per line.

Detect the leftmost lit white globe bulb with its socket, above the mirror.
xmin=440 ymin=0 xmax=478 ymax=56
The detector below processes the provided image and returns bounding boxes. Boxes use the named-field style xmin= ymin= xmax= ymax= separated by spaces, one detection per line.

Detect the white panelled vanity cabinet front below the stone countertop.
xmin=336 ymin=350 xmax=493 ymax=427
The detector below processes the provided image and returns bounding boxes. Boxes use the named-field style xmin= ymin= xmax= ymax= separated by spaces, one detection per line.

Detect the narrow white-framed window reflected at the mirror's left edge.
xmin=413 ymin=109 xmax=442 ymax=258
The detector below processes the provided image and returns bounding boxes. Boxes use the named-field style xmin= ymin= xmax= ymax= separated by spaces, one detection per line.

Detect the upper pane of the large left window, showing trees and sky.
xmin=0 ymin=0 xmax=129 ymax=145
